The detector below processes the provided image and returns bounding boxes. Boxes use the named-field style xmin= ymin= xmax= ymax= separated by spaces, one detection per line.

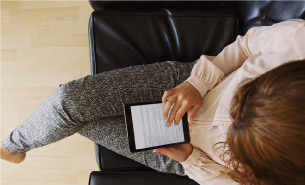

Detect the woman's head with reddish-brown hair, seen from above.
xmin=226 ymin=61 xmax=305 ymax=185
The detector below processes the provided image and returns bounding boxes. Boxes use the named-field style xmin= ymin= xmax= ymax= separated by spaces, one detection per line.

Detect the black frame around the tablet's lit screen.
xmin=124 ymin=101 xmax=190 ymax=153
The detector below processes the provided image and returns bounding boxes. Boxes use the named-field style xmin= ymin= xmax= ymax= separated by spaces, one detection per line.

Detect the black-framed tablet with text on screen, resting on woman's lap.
xmin=124 ymin=102 xmax=190 ymax=153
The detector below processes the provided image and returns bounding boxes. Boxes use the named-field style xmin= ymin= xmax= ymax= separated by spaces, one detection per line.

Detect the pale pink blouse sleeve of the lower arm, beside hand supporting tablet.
xmin=181 ymin=148 xmax=237 ymax=185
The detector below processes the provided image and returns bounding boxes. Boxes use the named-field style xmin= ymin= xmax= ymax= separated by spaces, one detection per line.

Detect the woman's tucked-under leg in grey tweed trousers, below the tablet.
xmin=78 ymin=116 xmax=186 ymax=175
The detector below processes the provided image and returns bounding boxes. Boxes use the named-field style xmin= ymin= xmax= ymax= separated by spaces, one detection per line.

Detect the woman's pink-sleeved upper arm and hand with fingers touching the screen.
xmin=162 ymin=19 xmax=305 ymax=124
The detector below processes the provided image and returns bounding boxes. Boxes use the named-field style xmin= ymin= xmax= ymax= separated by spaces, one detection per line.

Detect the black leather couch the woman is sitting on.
xmin=89 ymin=1 xmax=305 ymax=185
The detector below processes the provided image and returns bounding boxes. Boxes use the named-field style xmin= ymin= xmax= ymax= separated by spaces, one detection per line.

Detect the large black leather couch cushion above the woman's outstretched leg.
xmin=89 ymin=8 xmax=238 ymax=74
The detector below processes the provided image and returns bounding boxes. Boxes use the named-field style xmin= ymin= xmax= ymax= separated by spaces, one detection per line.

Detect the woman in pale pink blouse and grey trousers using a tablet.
xmin=1 ymin=20 xmax=305 ymax=185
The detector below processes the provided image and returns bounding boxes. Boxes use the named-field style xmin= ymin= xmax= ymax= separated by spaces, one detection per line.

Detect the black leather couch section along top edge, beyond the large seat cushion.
xmin=89 ymin=0 xmax=305 ymax=34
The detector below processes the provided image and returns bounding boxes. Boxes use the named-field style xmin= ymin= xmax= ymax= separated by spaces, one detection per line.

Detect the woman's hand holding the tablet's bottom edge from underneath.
xmin=153 ymin=143 xmax=193 ymax=162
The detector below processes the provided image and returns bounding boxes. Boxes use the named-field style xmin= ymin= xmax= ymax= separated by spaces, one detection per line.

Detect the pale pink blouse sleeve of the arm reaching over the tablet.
xmin=186 ymin=19 xmax=305 ymax=96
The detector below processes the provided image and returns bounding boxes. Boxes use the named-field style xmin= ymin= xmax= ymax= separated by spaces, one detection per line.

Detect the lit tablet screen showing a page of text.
xmin=130 ymin=103 xmax=185 ymax=150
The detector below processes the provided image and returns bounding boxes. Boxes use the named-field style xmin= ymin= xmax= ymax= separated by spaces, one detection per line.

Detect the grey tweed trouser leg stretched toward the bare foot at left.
xmin=3 ymin=62 xmax=194 ymax=173
